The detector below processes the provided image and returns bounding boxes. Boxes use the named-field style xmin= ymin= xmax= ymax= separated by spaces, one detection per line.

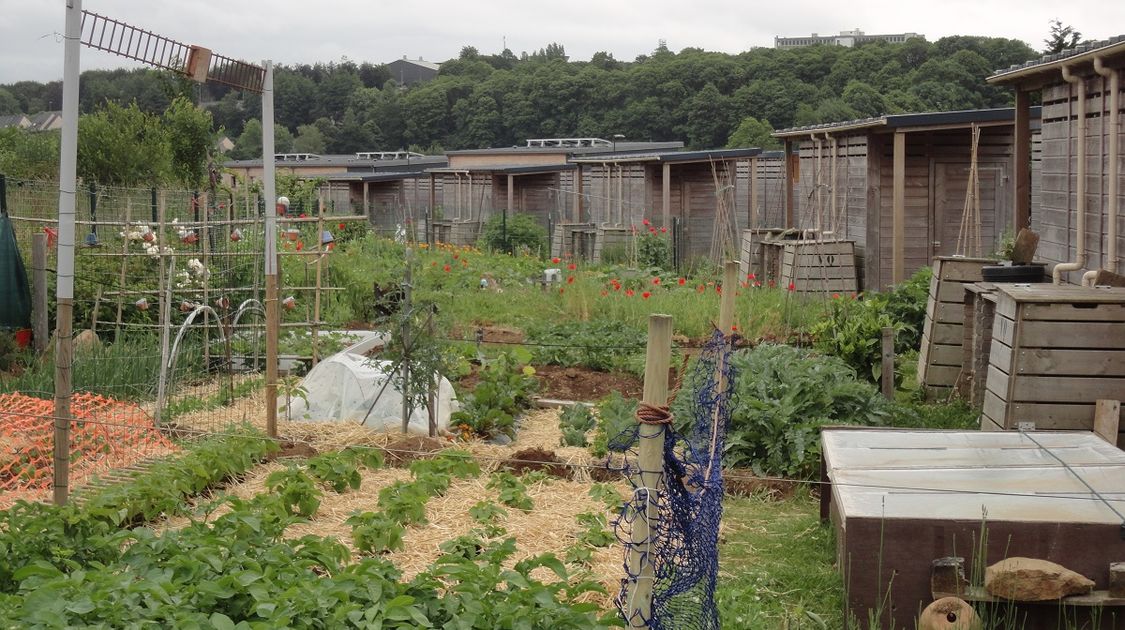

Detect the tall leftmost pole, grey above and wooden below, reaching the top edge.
xmin=54 ymin=0 xmax=82 ymax=505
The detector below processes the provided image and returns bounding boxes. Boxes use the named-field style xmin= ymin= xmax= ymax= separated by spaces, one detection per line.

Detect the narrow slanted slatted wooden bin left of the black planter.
xmin=918 ymin=257 xmax=995 ymax=398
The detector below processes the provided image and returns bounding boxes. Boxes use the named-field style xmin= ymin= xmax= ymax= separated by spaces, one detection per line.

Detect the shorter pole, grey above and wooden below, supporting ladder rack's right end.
xmin=262 ymin=60 xmax=281 ymax=438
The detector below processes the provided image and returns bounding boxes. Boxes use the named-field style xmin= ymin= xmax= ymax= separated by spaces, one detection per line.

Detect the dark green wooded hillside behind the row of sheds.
xmin=0 ymin=37 xmax=1035 ymax=156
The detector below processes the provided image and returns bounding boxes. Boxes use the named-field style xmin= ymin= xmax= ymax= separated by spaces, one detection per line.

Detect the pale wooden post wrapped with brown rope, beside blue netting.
xmin=626 ymin=315 xmax=672 ymax=628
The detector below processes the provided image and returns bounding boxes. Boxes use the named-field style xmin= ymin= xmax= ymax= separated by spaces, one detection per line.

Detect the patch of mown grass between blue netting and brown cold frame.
xmin=716 ymin=491 xmax=844 ymax=629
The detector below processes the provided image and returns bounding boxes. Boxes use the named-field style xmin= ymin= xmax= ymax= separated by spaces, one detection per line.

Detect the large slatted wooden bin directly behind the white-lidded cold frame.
xmin=981 ymin=285 xmax=1125 ymax=446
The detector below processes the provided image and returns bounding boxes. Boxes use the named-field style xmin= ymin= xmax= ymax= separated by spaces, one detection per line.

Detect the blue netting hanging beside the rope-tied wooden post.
xmin=610 ymin=332 xmax=734 ymax=630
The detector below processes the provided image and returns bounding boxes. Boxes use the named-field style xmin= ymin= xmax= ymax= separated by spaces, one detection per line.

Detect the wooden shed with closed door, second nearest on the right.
xmin=774 ymin=108 xmax=1038 ymax=289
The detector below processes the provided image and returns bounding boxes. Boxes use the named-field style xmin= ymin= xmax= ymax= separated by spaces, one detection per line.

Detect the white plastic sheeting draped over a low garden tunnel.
xmin=278 ymin=334 xmax=457 ymax=435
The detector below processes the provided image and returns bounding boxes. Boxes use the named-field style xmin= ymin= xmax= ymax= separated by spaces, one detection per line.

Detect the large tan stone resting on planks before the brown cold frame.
xmin=984 ymin=557 xmax=1094 ymax=602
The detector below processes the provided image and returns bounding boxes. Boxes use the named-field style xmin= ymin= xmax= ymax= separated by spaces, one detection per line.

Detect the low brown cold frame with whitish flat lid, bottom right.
xmin=820 ymin=428 xmax=1125 ymax=630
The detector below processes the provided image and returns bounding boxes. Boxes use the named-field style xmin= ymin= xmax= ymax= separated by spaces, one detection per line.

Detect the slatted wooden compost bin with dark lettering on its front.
xmin=777 ymin=241 xmax=860 ymax=295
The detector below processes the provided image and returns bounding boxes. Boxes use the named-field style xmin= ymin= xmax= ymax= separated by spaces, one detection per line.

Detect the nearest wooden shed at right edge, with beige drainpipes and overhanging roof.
xmin=988 ymin=35 xmax=1125 ymax=284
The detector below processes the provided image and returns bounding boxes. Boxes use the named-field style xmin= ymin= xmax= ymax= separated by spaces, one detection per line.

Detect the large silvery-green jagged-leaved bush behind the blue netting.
xmin=673 ymin=344 xmax=891 ymax=478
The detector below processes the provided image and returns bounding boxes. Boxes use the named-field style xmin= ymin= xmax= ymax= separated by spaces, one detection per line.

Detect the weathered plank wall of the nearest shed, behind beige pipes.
xmin=1032 ymin=79 xmax=1125 ymax=282
